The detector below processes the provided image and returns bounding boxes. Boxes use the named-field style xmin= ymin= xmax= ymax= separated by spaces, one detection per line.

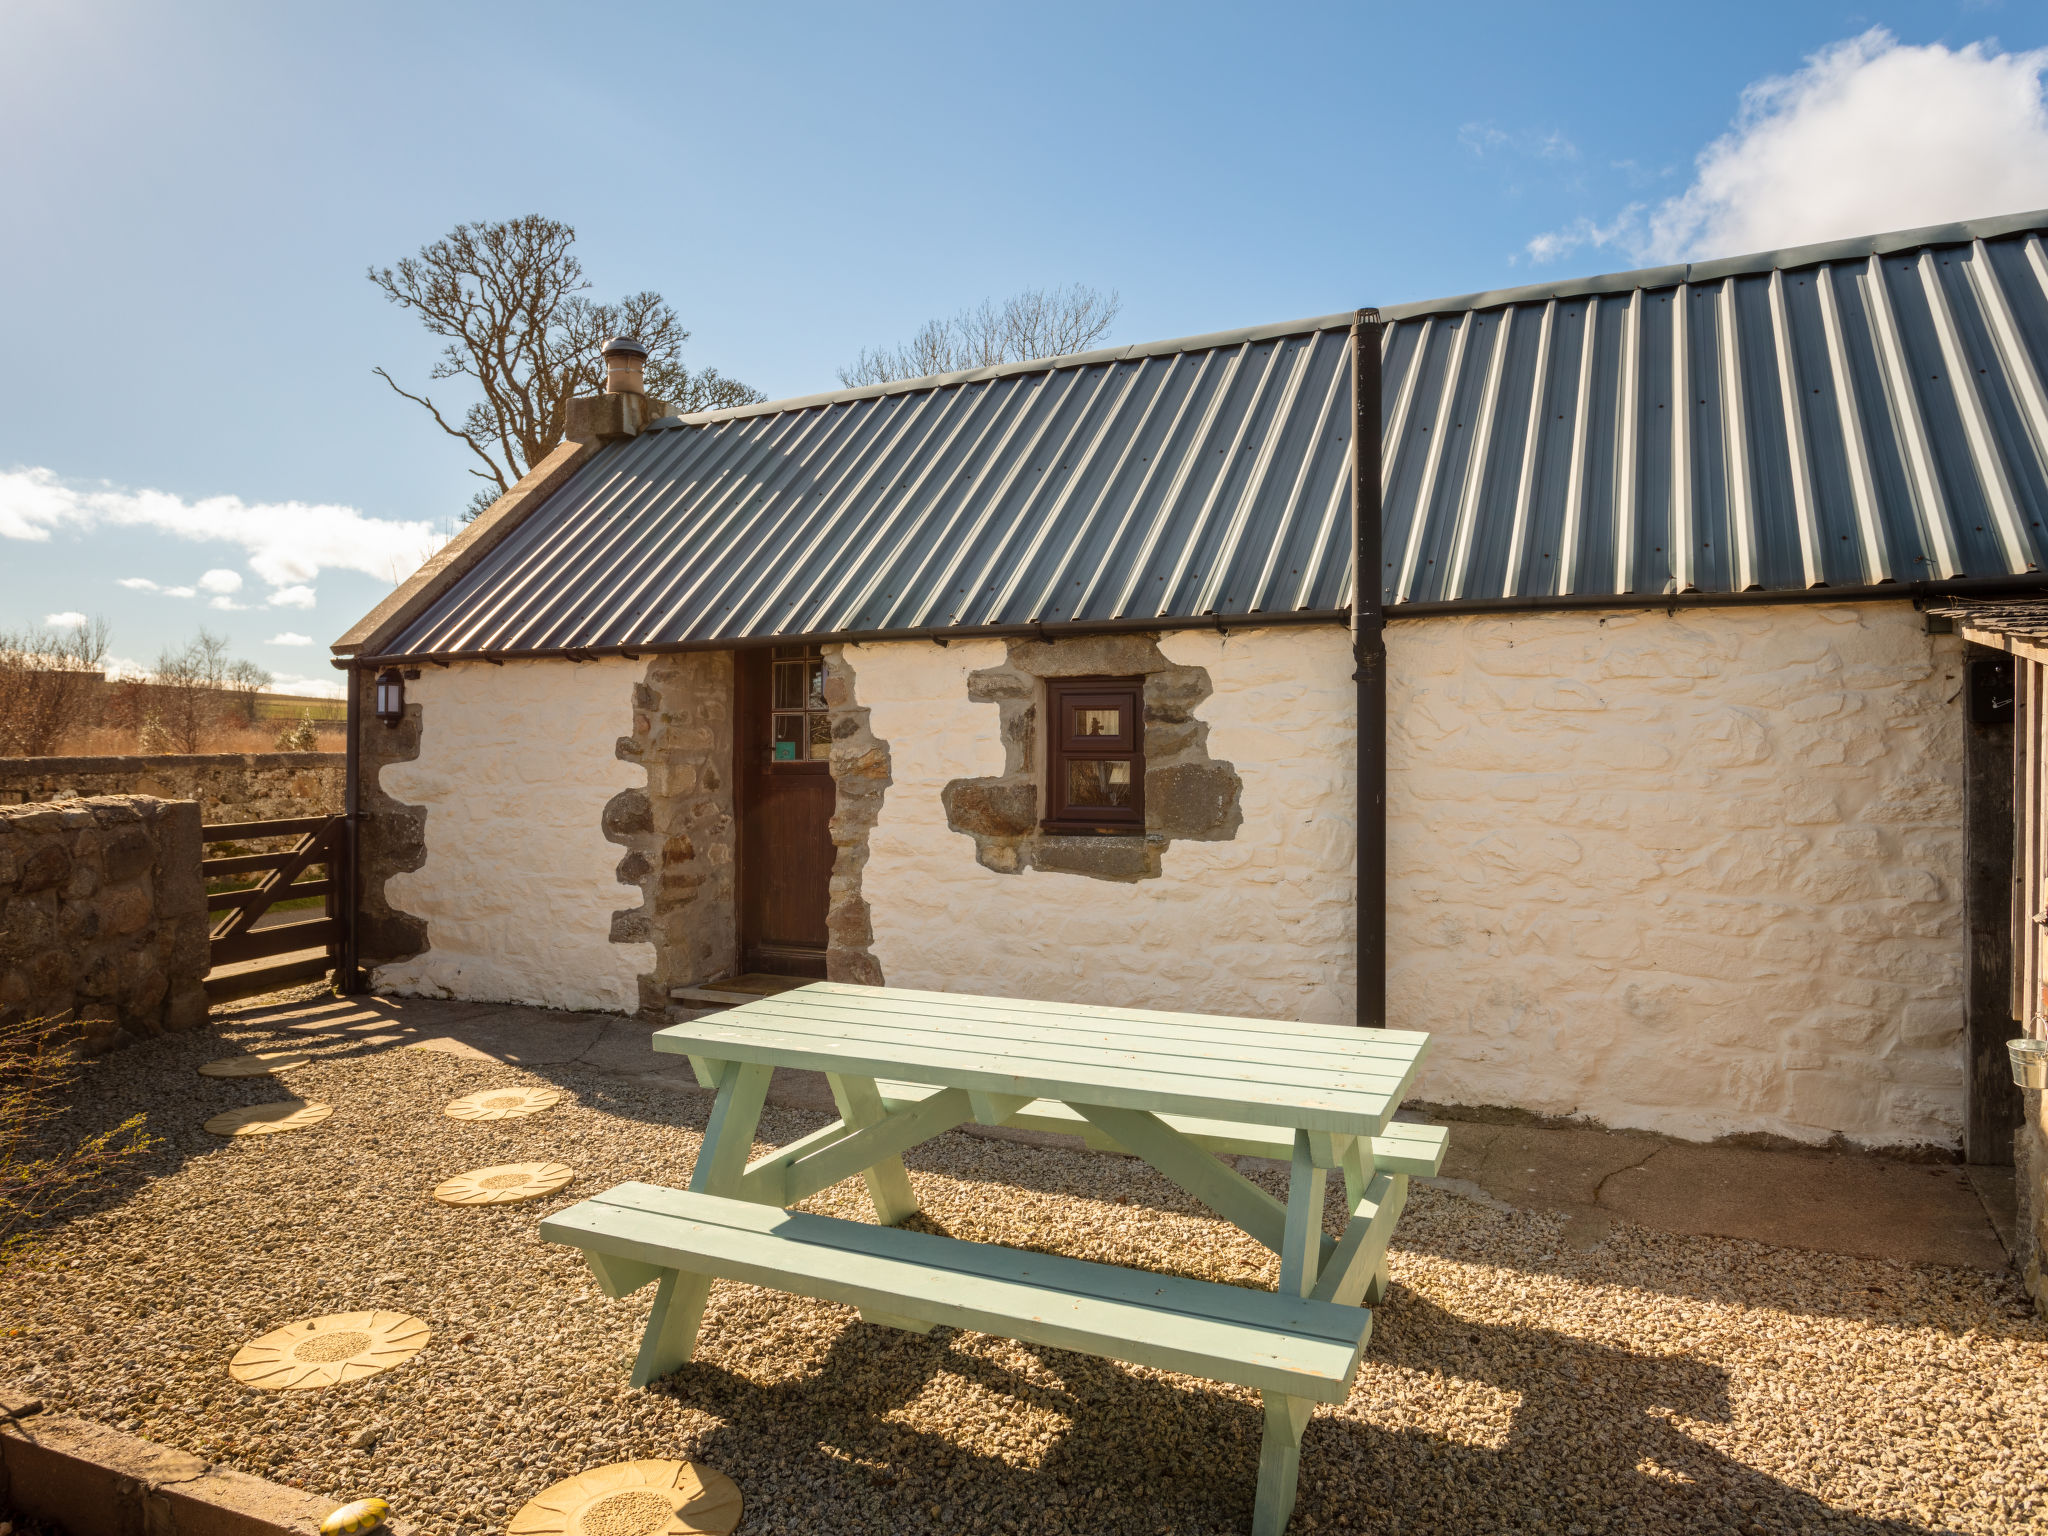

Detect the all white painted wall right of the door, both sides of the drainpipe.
xmin=846 ymin=602 xmax=1962 ymax=1145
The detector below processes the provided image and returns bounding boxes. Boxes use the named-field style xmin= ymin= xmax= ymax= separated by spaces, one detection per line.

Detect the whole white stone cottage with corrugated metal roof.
xmin=336 ymin=213 xmax=2048 ymax=1179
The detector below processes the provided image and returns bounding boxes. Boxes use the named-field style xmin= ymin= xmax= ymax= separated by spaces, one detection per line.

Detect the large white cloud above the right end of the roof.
xmin=1528 ymin=27 xmax=2048 ymax=262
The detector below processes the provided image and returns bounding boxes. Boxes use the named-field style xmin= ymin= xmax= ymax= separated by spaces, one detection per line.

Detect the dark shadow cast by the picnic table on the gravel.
xmin=653 ymin=1286 xmax=1929 ymax=1536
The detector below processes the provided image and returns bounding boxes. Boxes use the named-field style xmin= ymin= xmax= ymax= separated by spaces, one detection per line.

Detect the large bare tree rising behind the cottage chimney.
xmin=369 ymin=213 xmax=766 ymax=518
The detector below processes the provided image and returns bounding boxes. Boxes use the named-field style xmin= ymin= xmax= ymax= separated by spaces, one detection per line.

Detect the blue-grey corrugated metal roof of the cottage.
xmin=383 ymin=215 xmax=2048 ymax=655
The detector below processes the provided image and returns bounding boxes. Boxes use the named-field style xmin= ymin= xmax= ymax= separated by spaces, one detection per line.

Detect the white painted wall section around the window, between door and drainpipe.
xmin=846 ymin=629 xmax=1356 ymax=1036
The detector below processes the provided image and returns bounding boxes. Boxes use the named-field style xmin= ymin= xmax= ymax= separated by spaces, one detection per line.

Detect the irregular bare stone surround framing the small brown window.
xmin=940 ymin=635 xmax=1243 ymax=883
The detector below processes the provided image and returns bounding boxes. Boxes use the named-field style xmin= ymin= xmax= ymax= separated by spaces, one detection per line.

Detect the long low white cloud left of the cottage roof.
xmin=0 ymin=469 xmax=440 ymax=606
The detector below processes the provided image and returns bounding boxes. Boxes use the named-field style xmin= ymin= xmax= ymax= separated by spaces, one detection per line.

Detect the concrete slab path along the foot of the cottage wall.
xmin=215 ymin=995 xmax=2009 ymax=1270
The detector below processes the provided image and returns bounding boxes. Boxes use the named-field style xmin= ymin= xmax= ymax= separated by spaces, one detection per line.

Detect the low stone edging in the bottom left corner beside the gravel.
xmin=0 ymin=1386 xmax=412 ymax=1536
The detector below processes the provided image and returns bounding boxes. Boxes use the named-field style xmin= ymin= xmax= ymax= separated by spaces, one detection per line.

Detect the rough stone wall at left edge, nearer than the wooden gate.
xmin=0 ymin=795 xmax=207 ymax=1053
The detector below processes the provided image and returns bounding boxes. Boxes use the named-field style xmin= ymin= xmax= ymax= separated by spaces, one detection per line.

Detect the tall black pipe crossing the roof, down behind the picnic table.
xmin=1352 ymin=309 xmax=1386 ymax=1028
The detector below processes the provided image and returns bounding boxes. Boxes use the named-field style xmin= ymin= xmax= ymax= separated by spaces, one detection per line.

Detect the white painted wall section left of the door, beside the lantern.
xmin=373 ymin=657 xmax=653 ymax=1012
